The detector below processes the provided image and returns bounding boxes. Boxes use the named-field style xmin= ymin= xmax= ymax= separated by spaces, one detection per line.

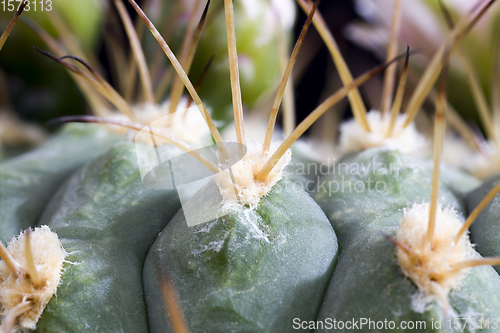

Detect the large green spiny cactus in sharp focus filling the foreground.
xmin=0 ymin=0 xmax=500 ymax=332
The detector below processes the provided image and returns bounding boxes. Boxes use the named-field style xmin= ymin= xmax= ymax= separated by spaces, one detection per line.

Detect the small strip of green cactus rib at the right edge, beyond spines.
xmin=465 ymin=174 xmax=500 ymax=274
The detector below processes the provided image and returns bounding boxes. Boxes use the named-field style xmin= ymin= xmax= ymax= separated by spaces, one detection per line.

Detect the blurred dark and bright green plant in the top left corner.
xmin=0 ymin=0 xmax=106 ymax=122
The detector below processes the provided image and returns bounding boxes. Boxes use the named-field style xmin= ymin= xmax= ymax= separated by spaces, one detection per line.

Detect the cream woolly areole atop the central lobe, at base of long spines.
xmin=215 ymin=141 xmax=292 ymax=210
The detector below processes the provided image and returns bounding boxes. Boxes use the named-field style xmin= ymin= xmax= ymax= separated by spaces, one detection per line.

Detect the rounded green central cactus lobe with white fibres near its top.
xmin=144 ymin=180 xmax=338 ymax=332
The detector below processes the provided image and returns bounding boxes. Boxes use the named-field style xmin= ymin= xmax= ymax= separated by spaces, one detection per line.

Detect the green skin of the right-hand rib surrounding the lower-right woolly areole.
xmin=315 ymin=149 xmax=500 ymax=332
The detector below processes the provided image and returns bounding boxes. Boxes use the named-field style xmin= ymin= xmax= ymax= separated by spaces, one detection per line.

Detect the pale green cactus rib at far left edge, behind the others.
xmin=0 ymin=124 xmax=119 ymax=241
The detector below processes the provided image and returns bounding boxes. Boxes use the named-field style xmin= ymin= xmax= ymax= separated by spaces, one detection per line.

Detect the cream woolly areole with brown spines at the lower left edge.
xmin=0 ymin=226 xmax=67 ymax=330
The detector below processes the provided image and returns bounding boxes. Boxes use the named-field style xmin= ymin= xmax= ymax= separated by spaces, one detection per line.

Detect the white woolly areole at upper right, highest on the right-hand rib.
xmin=340 ymin=110 xmax=427 ymax=154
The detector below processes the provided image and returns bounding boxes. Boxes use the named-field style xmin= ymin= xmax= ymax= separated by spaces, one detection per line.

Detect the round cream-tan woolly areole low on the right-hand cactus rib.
xmin=396 ymin=203 xmax=473 ymax=311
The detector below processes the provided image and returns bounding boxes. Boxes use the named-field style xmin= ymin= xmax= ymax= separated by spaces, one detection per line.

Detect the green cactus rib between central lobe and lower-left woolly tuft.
xmin=37 ymin=143 xmax=184 ymax=332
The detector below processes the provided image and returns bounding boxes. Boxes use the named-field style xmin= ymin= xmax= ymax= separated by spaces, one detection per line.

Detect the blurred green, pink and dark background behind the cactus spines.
xmin=0 ymin=0 xmax=500 ymax=141
